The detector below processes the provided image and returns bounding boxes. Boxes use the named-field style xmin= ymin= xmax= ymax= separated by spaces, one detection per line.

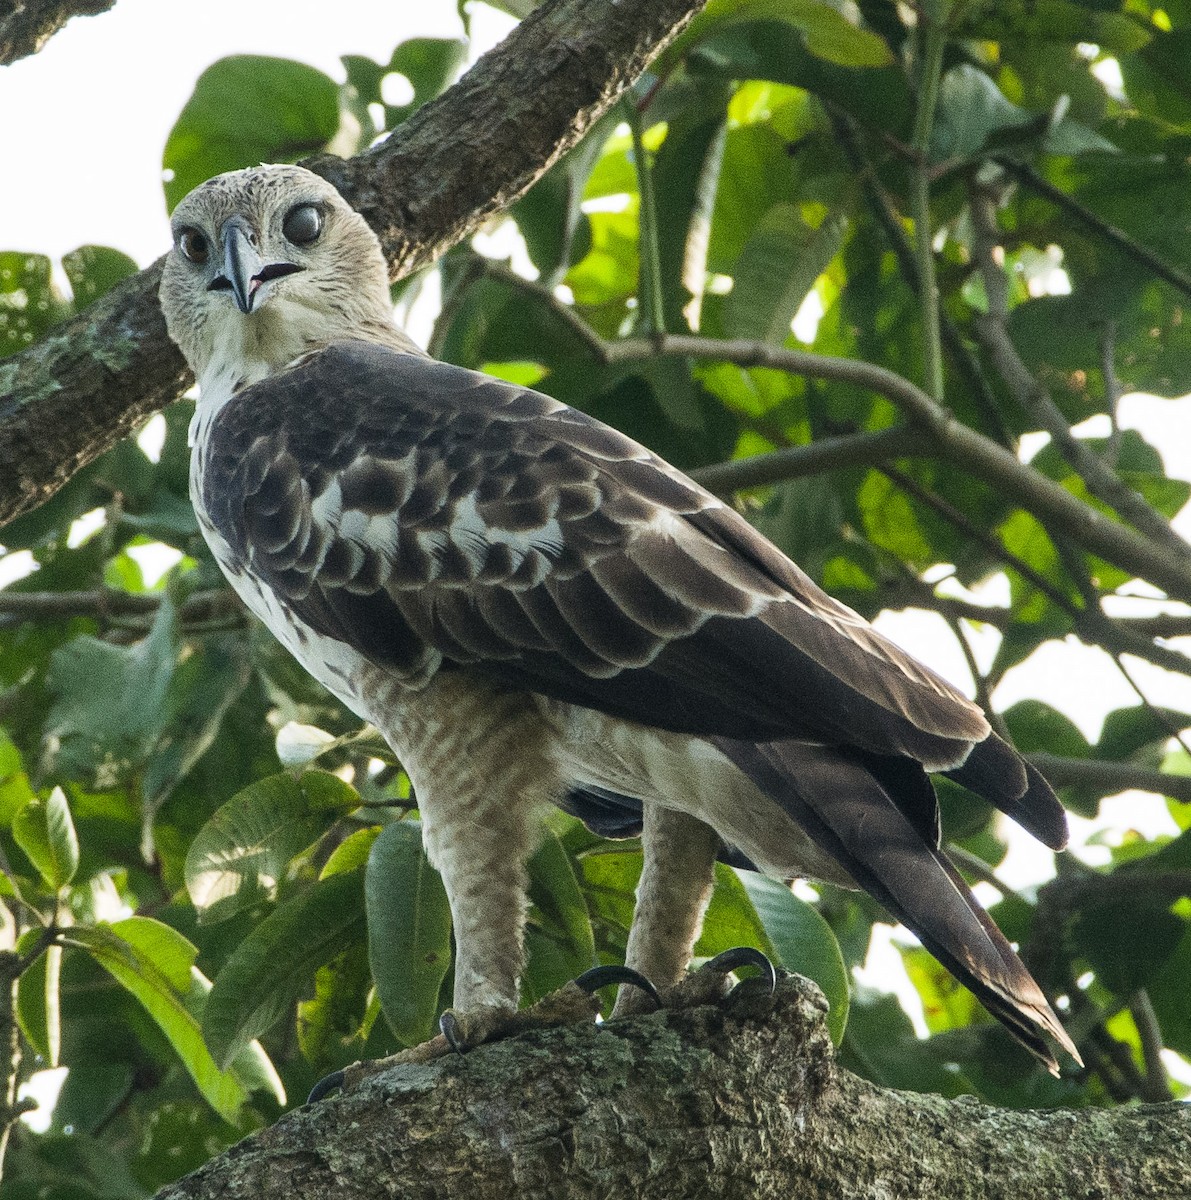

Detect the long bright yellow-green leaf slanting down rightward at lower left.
xmin=68 ymin=917 xmax=247 ymax=1124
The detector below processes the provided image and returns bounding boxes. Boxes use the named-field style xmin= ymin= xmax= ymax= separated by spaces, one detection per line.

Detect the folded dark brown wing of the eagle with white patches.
xmin=203 ymin=342 xmax=998 ymax=763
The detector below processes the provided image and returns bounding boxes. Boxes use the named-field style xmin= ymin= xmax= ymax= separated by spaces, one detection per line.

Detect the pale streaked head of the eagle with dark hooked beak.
xmin=161 ymin=166 xmax=395 ymax=390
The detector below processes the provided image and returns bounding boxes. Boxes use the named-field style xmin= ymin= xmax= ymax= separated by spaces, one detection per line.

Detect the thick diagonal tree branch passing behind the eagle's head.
xmin=0 ymin=0 xmax=704 ymax=524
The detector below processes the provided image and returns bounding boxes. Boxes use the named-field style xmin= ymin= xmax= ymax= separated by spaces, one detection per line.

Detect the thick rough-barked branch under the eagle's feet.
xmin=158 ymin=976 xmax=1191 ymax=1200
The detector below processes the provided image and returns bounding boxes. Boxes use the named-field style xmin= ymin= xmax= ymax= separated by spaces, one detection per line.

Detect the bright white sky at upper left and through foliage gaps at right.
xmin=0 ymin=0 xmax=1191 ymax=1113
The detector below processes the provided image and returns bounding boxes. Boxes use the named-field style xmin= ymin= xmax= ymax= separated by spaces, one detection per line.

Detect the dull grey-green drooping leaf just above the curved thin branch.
xmin=724 ymin=204 xmax=846 ymax=346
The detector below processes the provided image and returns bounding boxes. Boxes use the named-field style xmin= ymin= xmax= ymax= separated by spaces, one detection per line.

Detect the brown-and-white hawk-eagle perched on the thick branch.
xmin=161 ymin=166 xmax=1075 ymax=1069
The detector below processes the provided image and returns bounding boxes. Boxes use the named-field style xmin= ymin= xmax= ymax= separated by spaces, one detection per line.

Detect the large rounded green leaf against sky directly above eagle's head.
xmin=162 ymin=54 xmax=340 ymax=211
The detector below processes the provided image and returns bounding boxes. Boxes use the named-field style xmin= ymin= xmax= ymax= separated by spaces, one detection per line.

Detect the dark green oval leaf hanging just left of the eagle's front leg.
xmin=364 ymin=821 xmax=450 ymax=1046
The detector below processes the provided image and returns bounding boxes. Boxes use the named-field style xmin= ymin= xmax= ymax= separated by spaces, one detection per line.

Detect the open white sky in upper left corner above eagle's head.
xmin=0 ymin=0 xmax=497 ymax=266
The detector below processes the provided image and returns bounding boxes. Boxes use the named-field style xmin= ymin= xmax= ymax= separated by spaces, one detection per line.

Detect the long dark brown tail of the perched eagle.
xmin=716 ymin=738 xmax=1079 ymax=1074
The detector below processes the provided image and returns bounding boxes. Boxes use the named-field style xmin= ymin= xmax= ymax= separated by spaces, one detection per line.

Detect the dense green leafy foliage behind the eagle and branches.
xmin=0 ymin=0 xmax=1191 ymax=1198
